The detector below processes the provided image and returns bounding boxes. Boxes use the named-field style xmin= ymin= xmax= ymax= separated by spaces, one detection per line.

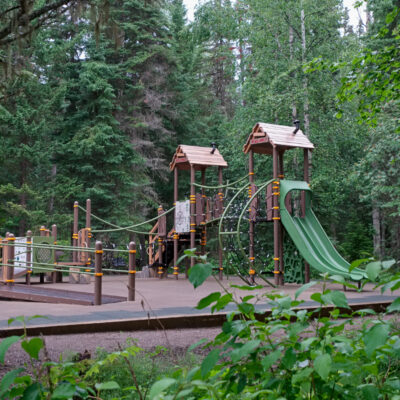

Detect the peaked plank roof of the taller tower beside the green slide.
xmin=243 ymin=122 xmax=314 ymax=154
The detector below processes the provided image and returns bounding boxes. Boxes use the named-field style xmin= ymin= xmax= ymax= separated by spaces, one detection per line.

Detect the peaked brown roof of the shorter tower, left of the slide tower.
xmin=169 ymin=144 xmax=228 ymax=171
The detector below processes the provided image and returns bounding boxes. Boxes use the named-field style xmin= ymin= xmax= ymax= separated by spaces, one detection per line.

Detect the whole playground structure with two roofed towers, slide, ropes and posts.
xmin=1 ymin=121 xmax=365 ymax=304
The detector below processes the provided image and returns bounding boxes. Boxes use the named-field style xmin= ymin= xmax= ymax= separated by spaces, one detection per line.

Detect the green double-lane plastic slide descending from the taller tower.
xmin=279 ymin=180 xmax=367 ymax=281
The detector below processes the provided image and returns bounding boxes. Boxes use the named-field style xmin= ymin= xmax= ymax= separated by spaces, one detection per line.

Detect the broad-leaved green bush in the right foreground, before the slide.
xmin=150 ymin=260 xmax=400 ymax=399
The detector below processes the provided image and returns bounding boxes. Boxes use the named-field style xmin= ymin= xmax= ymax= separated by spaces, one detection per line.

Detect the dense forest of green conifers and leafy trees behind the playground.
xmin=0 ymin=0 xmax=400 ymax=260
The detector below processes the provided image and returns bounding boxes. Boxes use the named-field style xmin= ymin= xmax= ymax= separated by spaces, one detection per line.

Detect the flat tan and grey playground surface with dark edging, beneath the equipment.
xmin=0 ymin=275 xmax=400 ymax=337
